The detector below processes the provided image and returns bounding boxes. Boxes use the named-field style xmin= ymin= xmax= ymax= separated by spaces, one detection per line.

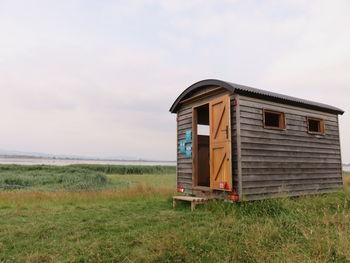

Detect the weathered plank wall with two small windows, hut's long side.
xmin=239 ymin=96 xmax=342 ymax=200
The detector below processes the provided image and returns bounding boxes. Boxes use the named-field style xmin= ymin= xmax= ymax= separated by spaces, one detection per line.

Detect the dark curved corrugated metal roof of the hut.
xmin=170 ymin=79 xmax=344 ymax=114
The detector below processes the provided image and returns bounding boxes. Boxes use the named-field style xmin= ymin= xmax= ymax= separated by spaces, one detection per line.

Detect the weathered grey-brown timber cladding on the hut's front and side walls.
xmin=177 ymin=87 xmax=342 ymax=200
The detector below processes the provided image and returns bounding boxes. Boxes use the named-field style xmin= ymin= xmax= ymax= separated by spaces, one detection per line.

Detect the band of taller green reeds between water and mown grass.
xmin=0 ymin=165 xmax=175 ymax=190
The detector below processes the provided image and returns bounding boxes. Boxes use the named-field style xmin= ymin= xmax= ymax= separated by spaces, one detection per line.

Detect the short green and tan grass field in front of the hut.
xmin=0 ymin=167 xmax=350 ymax=262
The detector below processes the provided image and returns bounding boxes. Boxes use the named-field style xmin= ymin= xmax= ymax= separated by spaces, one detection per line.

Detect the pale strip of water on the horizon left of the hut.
xmin=0 ymin=157 xmax=176 ymax=166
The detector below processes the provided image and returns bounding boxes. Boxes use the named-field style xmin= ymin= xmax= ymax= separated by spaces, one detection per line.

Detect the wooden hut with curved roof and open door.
xmin=170 ymin=79 xmax=344 ymax=201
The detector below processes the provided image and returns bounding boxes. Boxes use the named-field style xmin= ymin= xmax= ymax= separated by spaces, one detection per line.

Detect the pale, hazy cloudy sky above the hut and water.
xmin=0 ymin=0 xmax=350 ymax=163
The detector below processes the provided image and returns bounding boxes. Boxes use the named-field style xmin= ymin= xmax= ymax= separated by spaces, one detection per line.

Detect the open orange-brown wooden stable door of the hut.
xmin=209 ymin=95 xmax=232 ymax=191
